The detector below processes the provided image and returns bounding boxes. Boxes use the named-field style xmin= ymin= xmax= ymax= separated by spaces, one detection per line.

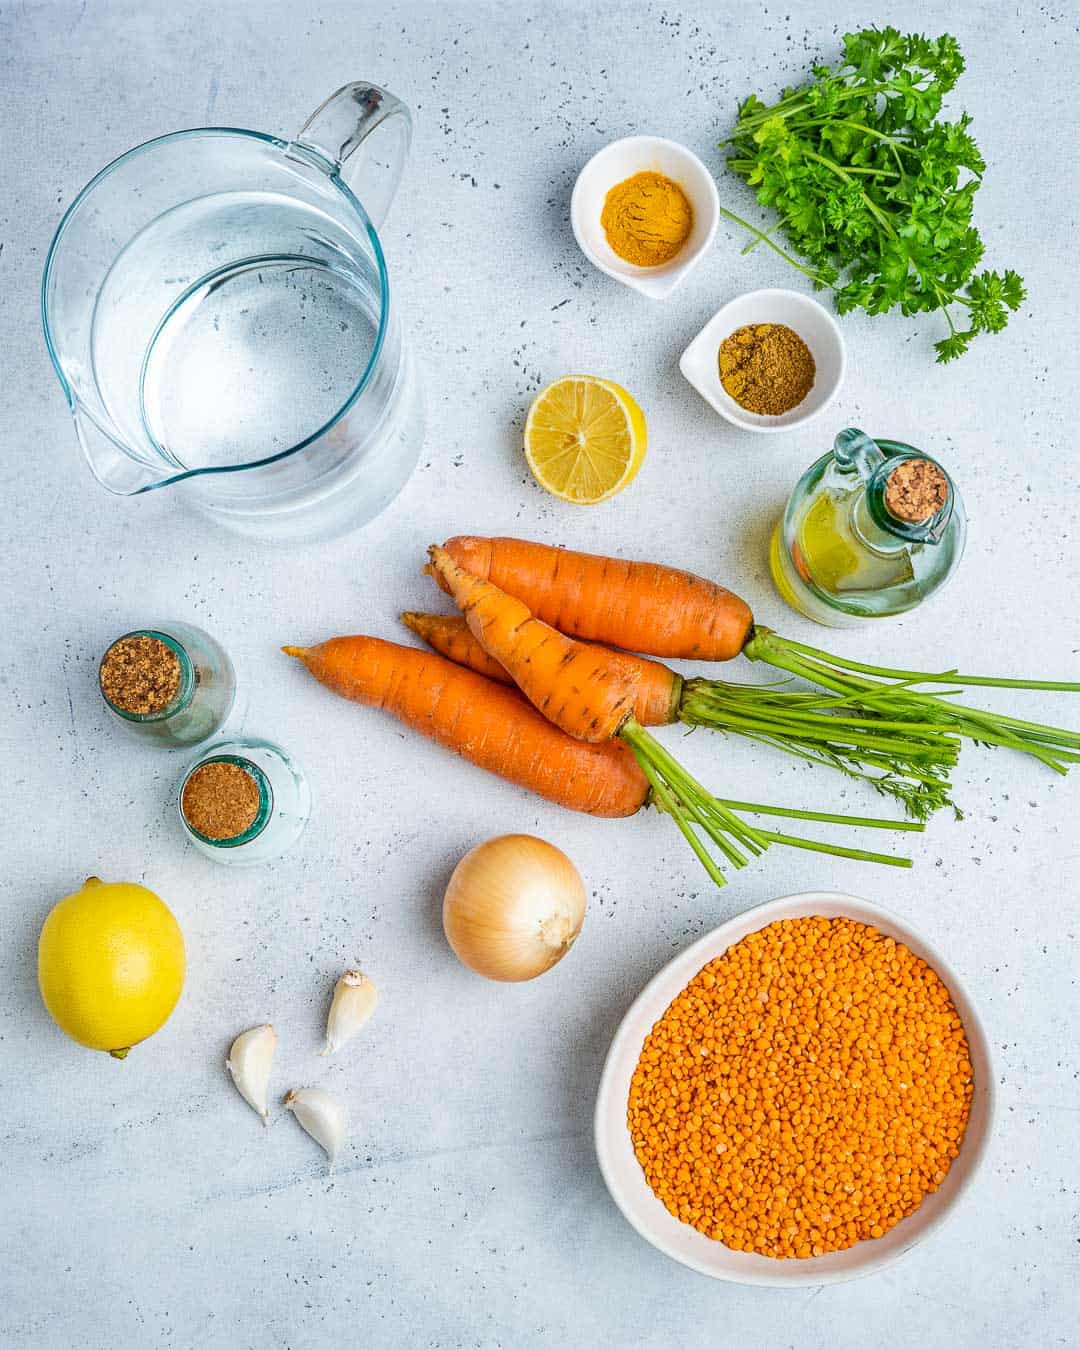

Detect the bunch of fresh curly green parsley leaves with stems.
xmin=721 ymin=28 xmax=1026 ymax=362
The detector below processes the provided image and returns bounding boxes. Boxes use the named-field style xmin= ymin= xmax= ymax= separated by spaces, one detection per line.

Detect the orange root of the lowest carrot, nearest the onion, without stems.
xmin=282 ymin=637 xmax=649 ymax=817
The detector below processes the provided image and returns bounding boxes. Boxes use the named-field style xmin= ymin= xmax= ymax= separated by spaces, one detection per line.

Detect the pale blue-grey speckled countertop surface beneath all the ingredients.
xmin=0 ymin=0 xmax=1080 ymax=1350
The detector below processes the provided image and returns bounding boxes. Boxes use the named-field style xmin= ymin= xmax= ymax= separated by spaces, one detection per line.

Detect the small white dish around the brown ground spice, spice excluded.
xmin=679 ymin=289 xmax=846 ymax=432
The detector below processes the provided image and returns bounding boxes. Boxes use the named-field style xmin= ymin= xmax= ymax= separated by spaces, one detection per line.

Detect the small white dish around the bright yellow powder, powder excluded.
xmin=570 ymin=136 xmax=720 ymax=300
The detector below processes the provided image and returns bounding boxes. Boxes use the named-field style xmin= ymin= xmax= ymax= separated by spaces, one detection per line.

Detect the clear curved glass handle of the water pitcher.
xmin=293 ymin=81 xmax=413 ymax=228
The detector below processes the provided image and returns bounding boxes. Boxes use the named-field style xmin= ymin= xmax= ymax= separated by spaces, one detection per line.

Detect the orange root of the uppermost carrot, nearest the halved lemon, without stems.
xmin=443 ymin=535 xmax=753 ymax=662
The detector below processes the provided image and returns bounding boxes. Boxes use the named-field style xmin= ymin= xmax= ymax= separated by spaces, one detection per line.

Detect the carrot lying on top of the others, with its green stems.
xmin=429 ymin=547 xmax=918 ymax=886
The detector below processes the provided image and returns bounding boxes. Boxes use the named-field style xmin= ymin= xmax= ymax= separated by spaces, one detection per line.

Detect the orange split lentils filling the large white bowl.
xmin=628 ymin=917 xmax=972 ymax=1257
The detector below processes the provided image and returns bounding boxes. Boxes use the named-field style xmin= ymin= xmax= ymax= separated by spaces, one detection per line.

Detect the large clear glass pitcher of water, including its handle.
xmin=42 ymin=84 xmax=423 ymax=540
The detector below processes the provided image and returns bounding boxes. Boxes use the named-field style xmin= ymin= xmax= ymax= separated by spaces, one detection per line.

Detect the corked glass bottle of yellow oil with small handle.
xmin=770 ymin=427 xmax=965 ymax=628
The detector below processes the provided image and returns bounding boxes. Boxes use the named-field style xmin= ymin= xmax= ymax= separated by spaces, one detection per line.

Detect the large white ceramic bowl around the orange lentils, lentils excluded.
xmin=594 ymin=891 xmax=994 ymax=1287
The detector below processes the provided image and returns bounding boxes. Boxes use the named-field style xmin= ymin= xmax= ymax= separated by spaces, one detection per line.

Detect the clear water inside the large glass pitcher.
xmin=90 ymin=192 xmax=379 ymax=468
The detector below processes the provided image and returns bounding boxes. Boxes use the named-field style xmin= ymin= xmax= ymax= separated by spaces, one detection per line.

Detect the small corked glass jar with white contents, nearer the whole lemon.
xmin=177 ymin=737 xmax=311 ymax=867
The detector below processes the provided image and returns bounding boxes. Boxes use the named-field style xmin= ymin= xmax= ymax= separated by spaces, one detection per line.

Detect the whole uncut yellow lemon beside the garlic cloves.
xmin=38 ymin=876 xmax=184 ymax=1060
